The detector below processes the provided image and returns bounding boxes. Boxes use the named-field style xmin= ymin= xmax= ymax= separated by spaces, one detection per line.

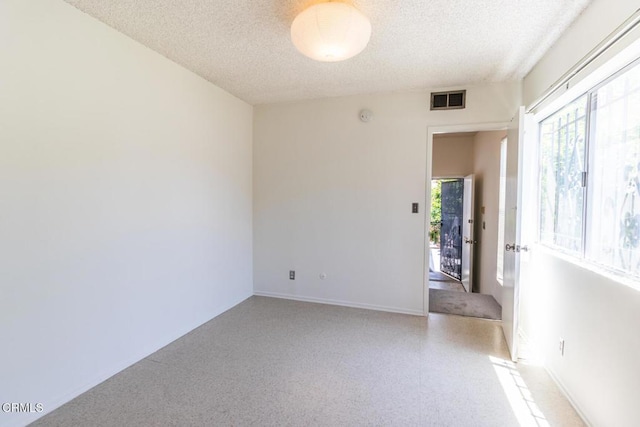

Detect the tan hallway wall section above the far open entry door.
xmin=431 ymin=133 xmax=474 ymax=178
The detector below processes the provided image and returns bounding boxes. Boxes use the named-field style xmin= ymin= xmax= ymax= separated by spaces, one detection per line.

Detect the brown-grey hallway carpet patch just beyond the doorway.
xmin=429 ymin=289 xmax=502 ymax=320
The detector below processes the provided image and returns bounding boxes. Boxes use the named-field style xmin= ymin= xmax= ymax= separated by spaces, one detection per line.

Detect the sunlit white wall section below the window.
xmin=522 ymin=246 xmax=640 ymax=426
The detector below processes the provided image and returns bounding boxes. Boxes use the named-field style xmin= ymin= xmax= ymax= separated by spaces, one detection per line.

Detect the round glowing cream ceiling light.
xmin=291 ymin=2 xmax=371 ymax=62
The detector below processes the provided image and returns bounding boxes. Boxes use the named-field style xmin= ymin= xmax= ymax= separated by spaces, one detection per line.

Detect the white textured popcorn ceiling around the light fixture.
xmin=65 ymin=0 xmax=591 ymax=104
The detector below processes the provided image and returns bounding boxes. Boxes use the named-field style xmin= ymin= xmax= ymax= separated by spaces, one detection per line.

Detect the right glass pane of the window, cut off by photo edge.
xmin=588 ymin=62 xmax=640 ymax=276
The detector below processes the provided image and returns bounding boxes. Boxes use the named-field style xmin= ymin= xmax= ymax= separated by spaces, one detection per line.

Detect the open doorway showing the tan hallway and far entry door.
xmin=428 ymin=130 xmax=506 ymax=320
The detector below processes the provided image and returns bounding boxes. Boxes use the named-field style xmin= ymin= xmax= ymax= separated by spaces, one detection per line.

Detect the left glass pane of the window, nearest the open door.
xmin=540 ymin=95 xmax=588 ymax=252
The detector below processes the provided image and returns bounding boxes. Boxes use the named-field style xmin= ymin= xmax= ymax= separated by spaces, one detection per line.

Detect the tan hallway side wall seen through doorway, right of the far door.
xmin=473 ymin=131 xmax=507 ymax=305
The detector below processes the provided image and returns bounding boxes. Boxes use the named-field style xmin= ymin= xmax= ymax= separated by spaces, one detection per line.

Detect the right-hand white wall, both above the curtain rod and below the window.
xmin=521 ymin=0 xmax=640 ymax=426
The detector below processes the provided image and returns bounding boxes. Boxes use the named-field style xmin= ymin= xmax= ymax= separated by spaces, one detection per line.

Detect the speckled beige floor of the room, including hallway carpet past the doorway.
xmin=30 ymin=297 xmax=584 ymax=427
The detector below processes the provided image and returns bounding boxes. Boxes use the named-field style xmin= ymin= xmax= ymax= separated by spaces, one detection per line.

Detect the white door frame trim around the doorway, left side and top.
xmin=422 ymin=121 xmax=510 ymax=317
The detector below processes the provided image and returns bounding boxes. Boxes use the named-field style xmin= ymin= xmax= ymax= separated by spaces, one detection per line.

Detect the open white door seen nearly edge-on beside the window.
xmin=502 ymin=107 xmax=524 ymax=361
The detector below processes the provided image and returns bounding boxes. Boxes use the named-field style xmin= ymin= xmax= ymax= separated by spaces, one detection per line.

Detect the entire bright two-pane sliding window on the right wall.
xmin=539 ymin=58 xmax=640 ymax=277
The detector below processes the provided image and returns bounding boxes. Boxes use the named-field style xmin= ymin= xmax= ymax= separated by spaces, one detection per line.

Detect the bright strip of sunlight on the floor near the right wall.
xmin=489 ymin=356 xmax=549 ymax=427
